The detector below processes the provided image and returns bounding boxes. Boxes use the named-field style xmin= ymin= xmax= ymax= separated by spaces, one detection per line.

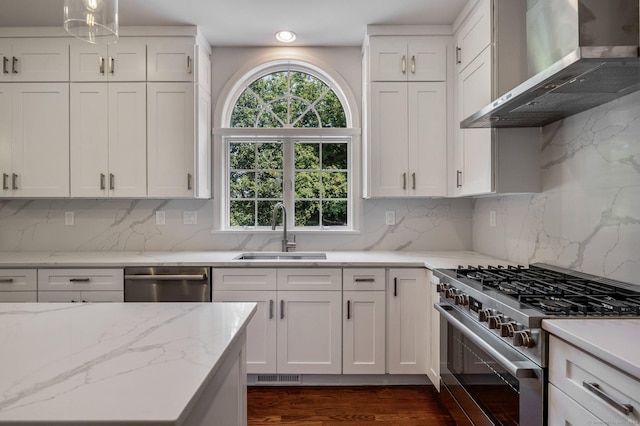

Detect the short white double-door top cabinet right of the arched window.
xmin=369 ymin=36 xmax=447 ymax=81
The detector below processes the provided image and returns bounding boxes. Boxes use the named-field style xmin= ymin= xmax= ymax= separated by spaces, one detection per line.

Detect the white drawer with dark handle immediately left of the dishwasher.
xmin=38 ymin=269 xmax=124 ymax=291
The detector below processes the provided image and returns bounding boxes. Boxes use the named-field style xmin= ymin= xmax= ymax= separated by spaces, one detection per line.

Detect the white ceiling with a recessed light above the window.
xmin=0 ymin=0 xmax=467 ymax=46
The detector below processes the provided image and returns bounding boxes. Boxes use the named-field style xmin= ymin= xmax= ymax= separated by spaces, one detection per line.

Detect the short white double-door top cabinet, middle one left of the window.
xmin=70 ymin=37 xmax=147 ymax=81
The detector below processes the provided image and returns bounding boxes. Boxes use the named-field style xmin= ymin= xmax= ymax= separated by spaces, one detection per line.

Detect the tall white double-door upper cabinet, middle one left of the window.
xmin=71 ymin=83 xmax=147 ymax=198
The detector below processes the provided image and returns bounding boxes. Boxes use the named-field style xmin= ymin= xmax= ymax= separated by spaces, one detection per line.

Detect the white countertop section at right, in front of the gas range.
xmin=542 ymin=318 xmax=640 ymax=379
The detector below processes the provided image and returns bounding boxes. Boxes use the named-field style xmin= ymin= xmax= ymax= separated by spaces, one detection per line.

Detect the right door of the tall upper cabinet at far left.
xmin=11 ymin=83 xmax=69 ymax=198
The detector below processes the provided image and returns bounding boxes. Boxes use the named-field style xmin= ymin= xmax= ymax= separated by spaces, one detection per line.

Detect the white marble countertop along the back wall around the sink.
xmin=0 ymin=251 xmax=511 ymax=269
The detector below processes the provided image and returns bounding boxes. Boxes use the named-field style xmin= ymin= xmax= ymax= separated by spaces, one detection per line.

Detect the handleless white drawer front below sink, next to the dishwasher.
xmin=211 ymin=268 xmax=277 ymax=291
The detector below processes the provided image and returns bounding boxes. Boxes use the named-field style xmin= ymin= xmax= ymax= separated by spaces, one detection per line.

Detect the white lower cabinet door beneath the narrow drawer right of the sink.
xmin=342 ymin=291 xmax=386 ymax=374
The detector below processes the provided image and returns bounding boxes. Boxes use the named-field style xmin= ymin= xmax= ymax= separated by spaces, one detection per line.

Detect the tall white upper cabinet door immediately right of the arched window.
xmin=368 ymin=83 xmax=409 ymax=197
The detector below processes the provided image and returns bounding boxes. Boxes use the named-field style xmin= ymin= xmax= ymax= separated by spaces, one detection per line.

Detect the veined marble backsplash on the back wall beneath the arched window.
xmin=0 ymin=199 xmax=473 ymax=251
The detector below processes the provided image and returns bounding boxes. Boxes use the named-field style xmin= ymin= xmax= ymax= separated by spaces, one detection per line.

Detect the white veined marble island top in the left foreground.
xmin=0 ymin=303 xmax=255 ymax=426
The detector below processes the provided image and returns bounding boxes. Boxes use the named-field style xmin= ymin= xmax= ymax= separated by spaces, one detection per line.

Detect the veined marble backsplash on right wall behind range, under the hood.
xmin=472 ymin=92 xmax=640 ymax=285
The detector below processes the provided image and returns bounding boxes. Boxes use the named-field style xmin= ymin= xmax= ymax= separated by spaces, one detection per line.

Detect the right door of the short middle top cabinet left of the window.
xmin=106 ymin=38 xmax=147 ymax=81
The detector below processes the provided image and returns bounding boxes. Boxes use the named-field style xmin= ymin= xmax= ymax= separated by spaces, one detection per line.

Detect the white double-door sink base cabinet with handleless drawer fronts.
xmin=212 ymin=268 xmax=342 ymax=374
